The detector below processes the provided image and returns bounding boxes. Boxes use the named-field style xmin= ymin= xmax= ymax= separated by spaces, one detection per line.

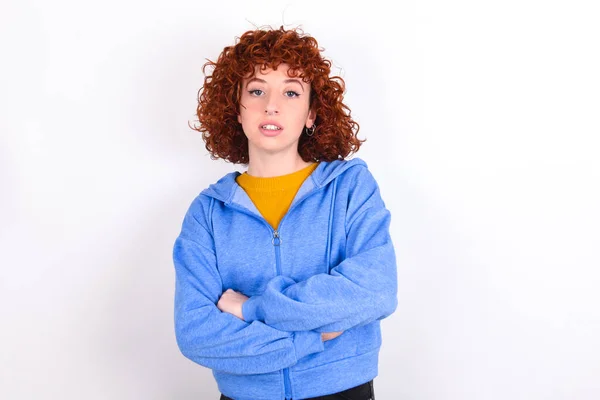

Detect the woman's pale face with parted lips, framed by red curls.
xmin=238 ymin=64 xmax=316 ymax=159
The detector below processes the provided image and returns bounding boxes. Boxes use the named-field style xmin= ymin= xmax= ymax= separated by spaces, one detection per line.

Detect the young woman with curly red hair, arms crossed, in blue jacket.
xmin=173 ymin=27 xmax=397 ymax=400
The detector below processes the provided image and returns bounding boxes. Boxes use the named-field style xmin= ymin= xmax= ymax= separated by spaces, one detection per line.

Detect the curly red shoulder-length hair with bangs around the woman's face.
xmin=191 ymin=26 xmax=366 ymax=164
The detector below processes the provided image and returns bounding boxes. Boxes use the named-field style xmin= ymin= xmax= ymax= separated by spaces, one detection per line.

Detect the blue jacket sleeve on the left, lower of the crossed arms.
xmin=173 ymin=201 xmax=324 ymax=374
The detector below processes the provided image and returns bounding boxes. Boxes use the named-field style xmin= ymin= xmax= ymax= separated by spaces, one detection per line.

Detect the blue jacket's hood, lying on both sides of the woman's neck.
xmin=200 ymin=157 xmax=367 ymax=204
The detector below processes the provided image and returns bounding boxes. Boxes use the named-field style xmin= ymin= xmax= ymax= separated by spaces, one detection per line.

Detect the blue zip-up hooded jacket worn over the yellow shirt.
xmin=173 ymin=158 xmax=397 ymax=400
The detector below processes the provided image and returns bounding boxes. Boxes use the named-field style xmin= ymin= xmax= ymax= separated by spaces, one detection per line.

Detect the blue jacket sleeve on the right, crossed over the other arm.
xmin=242 ymin=167 xmax=398 ymax=332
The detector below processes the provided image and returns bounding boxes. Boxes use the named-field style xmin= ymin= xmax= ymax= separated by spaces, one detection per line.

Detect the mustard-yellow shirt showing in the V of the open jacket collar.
xmin=236 ymin=163 xmax=319 ymax=229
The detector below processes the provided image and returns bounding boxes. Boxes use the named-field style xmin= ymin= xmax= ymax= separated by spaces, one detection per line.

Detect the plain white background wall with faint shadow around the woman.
xmin=0 ymin=0 xmax=600 ymax=400
